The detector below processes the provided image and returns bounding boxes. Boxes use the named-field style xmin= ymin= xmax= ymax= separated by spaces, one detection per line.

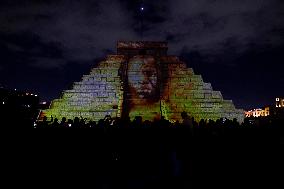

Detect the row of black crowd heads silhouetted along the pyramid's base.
xmin=34 ymin=112 xmax=284 ymax=134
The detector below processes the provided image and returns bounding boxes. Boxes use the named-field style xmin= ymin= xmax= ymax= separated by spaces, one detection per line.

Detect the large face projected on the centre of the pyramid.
xmin=128 ymin=57 xmax=158 ymax=101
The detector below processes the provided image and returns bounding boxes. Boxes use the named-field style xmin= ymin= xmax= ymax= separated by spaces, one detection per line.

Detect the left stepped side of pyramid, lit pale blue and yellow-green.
xmin=43 ymin=55 xmax=125 ymax=121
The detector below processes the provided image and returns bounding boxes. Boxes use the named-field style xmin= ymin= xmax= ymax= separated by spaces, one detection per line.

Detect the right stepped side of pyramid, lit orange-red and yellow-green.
xmin=161 ymin=56 xmax=244 ymax=123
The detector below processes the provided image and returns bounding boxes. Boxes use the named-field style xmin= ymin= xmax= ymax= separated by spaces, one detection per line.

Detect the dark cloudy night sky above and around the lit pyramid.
xmin=0 ymin=0 xmax=284 ymax=109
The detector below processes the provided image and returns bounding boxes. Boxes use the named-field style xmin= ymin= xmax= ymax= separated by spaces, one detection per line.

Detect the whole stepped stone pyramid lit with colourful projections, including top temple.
xmin=42 ymin=41 xmax=244 ymax=122
